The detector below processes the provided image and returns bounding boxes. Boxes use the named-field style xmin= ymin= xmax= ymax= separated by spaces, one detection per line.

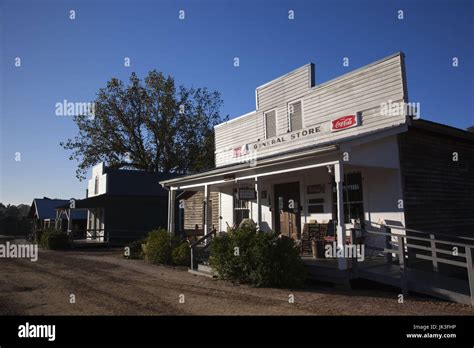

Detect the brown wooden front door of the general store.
xmin=273 ymin=182 xmax=301 ymax=239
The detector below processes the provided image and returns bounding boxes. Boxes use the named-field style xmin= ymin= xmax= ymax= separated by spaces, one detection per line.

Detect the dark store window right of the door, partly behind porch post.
xmin=333 ymin=172 xmax=364 ymax=224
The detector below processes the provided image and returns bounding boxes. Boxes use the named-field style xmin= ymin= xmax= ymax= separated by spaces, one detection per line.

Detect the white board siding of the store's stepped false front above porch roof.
xmin=215 ymin=54 xmax=407 ymax=167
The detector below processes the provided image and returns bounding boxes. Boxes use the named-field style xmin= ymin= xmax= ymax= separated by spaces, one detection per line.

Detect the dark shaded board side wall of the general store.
xmin=398 ymin=128 xmax=474 ymax=237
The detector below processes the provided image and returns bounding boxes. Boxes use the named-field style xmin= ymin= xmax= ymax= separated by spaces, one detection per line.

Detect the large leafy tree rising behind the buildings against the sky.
xmin=60 ymin=70 xmax=227 ymax=180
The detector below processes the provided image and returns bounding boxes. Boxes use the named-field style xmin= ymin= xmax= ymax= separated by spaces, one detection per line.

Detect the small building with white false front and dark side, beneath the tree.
xmin=59 ymin=163 xmax=172 ymax=245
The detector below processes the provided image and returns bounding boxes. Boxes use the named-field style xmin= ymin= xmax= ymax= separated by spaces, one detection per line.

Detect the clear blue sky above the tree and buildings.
xmin=0 ymin=0 xmax=474 ymax=204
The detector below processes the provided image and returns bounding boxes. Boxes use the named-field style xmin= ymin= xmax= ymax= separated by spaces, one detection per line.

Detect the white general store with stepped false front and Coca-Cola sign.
xmin=161 ymin=53 xmax=474 ymax=272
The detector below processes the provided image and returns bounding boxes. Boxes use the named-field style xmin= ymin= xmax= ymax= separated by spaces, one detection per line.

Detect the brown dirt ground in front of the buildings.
xmin=0 ymin=242 xmax=474 ymax=315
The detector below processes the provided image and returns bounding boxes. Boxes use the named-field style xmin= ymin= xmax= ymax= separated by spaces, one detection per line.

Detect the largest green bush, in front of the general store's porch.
xmin=210 ymin=226 xmax=306 ymax=288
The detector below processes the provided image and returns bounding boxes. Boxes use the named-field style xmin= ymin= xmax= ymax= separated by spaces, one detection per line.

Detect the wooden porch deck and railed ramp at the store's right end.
xmin=301 ymin=224 xmax=474 ymax=305
